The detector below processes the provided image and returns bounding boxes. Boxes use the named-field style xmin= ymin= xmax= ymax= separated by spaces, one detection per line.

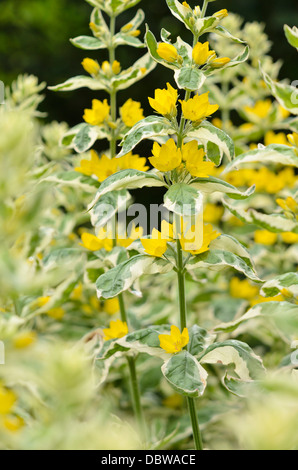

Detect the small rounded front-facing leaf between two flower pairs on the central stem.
xmin=164 ymin=183 xmax=203 ymax=216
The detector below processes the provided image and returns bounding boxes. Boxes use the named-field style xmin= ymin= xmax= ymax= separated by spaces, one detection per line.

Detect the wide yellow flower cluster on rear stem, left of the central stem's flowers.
xmin=75 ymin=150 xmax=149 ymax=183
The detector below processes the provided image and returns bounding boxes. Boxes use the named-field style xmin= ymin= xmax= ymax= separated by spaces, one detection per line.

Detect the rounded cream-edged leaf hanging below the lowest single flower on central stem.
xmin=161 ymin=351 xmax=208 ymax=397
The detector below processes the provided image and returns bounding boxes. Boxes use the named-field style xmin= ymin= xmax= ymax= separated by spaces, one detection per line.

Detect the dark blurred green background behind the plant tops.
xmin=0 ymin=0 xmax=298 ymax=125
